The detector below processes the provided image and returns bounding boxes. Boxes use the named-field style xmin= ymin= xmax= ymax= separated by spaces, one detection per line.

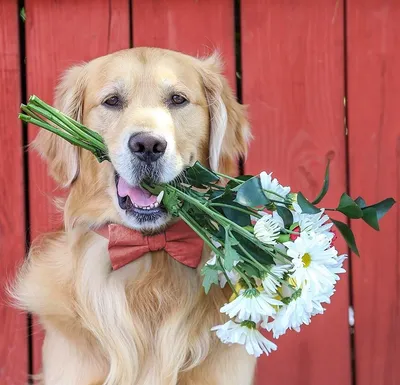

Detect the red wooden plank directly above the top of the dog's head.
xmin=133 ymin=0 xmax=236 ymax=88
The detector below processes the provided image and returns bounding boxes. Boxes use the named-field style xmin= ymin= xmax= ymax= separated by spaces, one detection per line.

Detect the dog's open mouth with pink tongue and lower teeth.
xmin=115 ymin=173 xmax=166 ymax=222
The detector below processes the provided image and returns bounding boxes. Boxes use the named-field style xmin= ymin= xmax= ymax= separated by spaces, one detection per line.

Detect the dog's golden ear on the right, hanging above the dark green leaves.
xmin=200 ymin=53 xmax=251 ymax=173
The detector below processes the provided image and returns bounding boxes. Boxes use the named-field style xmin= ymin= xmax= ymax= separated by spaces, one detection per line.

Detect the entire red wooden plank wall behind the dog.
xmin=0 ymin=0 xmax=400 ymax=385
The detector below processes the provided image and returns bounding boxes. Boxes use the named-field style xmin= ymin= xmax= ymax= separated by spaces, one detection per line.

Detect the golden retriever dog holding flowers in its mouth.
xmin=13 ymin=48 xmax=255 ymax=385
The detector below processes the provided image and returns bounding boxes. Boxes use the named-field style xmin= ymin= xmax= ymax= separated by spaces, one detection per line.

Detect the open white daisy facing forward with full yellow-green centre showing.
xmin=284 ymin=234 xmax=337 ymax=294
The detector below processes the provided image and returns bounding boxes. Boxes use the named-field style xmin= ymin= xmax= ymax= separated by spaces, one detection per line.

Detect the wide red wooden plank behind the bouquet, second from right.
xmin=241 ymin=0 xmax=351 ymax=385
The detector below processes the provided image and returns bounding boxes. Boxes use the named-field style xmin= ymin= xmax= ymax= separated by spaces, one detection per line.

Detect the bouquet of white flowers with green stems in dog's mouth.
xmin=20 ymin=96 xmax=395 ymax=357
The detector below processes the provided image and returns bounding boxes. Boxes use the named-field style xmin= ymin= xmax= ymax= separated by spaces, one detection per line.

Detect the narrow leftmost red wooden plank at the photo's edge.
xmin=0 ymin=1 xmax=28 ymax=385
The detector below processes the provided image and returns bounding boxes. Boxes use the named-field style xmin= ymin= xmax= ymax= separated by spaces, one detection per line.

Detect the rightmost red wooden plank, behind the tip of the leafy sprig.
xmin=347 ymin=0 xmax=400 ymax=385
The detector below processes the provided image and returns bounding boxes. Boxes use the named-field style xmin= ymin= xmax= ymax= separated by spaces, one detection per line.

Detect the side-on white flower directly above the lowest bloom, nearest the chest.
xmin=221 ymin=289 xmax=282 ymax=323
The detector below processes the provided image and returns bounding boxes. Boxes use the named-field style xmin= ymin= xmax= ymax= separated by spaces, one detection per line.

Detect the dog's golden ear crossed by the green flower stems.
xmin=32 ymin=65 xmax=86 ymax=187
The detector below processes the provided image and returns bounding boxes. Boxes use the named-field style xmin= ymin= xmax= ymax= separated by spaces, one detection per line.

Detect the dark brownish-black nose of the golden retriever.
xmin=128 ymin=132 xmax=167 ymax=163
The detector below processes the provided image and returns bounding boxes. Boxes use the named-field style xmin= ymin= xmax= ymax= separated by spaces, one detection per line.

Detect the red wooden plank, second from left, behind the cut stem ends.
xmin=25 ymin=0 xmax=130 ymax=373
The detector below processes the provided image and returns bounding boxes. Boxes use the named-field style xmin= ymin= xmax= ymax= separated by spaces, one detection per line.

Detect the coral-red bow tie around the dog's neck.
xmin=97 ymin=221 xmax=203 ymax=270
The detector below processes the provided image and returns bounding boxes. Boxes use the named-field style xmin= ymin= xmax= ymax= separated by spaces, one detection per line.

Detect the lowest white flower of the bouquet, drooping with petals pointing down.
xmin=211 ymin=321 xmax=277 ymax=357
